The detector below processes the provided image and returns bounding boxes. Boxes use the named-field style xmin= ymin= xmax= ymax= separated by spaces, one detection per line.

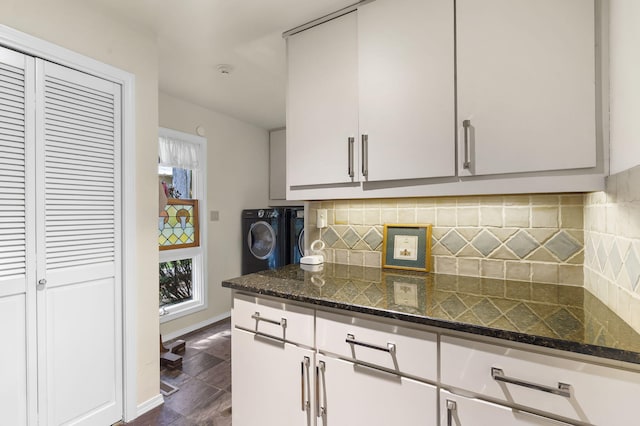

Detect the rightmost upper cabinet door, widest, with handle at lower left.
xmin=456 ymin=0 xmax=596 ymax=175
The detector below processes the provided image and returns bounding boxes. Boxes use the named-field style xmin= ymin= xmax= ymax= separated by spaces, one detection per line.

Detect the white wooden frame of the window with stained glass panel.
xmin=156 ymin=127 xmax=208 ymax=324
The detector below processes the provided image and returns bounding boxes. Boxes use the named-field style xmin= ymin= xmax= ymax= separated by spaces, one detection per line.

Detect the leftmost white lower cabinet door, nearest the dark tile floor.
xmin=231 ymin=328 xmax=314 ymax=426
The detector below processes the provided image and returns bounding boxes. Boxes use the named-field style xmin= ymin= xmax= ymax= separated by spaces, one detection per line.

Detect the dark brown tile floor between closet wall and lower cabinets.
xmin=126 ymin=319 xmax=231 ymax=426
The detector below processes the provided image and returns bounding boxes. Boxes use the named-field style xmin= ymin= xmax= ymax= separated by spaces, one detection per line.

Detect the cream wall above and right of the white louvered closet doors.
xmin=0 ymin=0 xmax=160 ymax=404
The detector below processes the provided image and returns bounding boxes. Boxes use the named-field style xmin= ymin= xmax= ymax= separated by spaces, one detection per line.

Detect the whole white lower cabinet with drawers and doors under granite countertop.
xmin=232 ymin=293 xmax=640 ymax=426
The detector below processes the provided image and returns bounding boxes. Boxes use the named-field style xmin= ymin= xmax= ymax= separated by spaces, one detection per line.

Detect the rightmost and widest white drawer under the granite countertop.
xmin=440 ymin=336 xmax=640 ymax=425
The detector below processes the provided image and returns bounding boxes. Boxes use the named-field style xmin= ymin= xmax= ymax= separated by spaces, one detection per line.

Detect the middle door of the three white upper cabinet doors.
xmin=358 ymin=0 xmax=455 ymax=181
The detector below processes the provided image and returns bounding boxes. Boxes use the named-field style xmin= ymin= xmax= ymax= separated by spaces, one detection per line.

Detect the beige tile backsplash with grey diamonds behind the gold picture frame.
xmin=307 ymin=194 xmax=584 ymax=285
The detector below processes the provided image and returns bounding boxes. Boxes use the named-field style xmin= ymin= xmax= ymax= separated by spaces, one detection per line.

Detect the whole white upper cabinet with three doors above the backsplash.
xmin=286 ymin=0 xmax=608 ymax=200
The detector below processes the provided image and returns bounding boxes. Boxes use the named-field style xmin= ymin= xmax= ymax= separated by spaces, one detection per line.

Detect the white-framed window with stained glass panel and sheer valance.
xmin=158 ymin=128 xmax=207 ymax=322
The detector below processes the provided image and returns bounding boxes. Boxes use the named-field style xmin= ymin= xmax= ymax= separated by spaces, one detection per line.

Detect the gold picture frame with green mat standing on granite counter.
xmin=382 ymin=223 xmax=432 ymax=272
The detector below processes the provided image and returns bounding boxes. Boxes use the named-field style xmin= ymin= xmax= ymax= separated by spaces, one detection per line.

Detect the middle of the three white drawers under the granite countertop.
xmin=316 ymin=312 xmax=438 ymax=380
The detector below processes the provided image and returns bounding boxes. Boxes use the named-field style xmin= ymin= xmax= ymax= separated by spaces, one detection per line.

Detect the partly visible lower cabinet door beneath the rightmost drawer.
xmin=440 ymin=391 xmax=569 ymax=426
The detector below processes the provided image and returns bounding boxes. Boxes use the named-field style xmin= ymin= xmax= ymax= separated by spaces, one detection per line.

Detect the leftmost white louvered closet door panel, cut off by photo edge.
xmin=0 ymin=43 xmax=36 ymax=425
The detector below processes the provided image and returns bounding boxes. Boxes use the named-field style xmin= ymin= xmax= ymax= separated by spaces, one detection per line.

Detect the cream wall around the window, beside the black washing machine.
xmin=161 ymin=93 xmax=269 ymax=335
